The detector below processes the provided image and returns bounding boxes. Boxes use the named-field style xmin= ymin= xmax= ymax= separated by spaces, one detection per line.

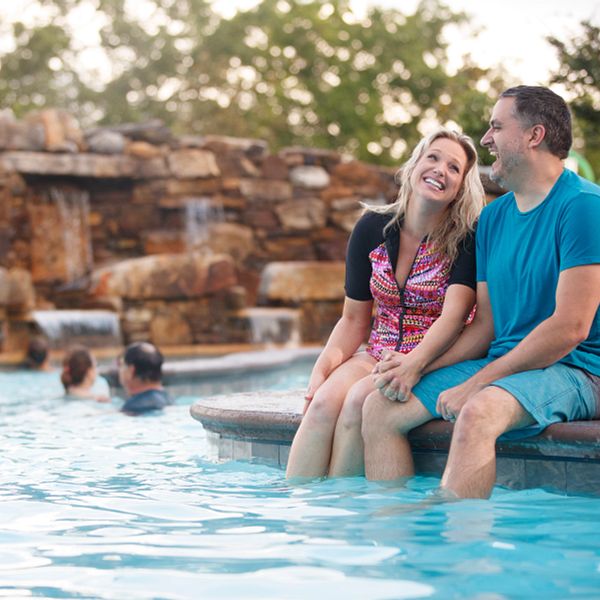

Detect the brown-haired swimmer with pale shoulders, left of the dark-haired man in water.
xmin=60 ymin=346 xmax=110 ymax=402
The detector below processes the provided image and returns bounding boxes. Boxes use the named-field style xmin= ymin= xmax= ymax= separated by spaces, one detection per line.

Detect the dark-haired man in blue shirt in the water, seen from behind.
xmin=119 ymin=342 xmax=173 ymax=415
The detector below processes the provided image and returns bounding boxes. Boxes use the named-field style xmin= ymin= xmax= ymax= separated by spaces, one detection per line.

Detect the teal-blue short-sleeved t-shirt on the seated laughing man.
xmin=476 ymin=169 xmax=600 ymax=375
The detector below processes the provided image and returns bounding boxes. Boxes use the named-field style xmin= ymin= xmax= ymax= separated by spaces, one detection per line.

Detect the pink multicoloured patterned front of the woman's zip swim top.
xmin=367 ymin=242 xmax=452 ymax=360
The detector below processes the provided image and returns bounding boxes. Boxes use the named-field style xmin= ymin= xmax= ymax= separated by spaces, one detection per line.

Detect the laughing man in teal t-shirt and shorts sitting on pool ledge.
xmin=363 ymin=86 xmax=600 ymax=498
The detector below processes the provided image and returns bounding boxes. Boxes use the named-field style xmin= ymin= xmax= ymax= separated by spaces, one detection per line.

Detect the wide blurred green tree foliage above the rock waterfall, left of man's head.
xmin=0 ymin=0 xmax=503 ymax=164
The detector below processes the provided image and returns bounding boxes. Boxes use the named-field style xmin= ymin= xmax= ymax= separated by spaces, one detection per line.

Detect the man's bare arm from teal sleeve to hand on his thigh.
xmin=438 ymin=265 xmax=600 ymax=415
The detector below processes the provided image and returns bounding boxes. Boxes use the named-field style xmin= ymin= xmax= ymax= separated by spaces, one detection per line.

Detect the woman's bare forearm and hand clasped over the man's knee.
xmin=374 ymin=284 xmax=475 ymax=401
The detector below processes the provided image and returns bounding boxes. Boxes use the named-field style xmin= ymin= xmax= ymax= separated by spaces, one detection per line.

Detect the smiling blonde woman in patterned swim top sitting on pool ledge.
xmin=287 ymin=129 xmax=485 ymax=478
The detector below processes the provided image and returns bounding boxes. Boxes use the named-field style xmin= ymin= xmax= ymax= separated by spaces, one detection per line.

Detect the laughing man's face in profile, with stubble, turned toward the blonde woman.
xmin=481 ymin=98 xmax=528 ymax=189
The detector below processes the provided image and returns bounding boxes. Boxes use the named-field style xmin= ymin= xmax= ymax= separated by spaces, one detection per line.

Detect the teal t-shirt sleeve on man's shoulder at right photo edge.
xmin=559 ymin=192 xmax=600 ymax=271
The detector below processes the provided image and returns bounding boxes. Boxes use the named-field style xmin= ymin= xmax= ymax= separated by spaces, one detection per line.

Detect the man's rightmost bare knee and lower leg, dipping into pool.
xmin=441 ymin=386 xmax=535 ymax=498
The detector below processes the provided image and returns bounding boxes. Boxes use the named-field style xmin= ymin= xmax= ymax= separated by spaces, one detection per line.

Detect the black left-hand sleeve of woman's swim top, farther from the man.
xmin=345 ymin=212 xmax=389 ymax=300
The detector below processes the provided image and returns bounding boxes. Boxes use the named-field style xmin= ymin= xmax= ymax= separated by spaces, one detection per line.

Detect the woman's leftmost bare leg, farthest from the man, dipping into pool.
xmin=286 ymin=353 xmax=375 ymax=478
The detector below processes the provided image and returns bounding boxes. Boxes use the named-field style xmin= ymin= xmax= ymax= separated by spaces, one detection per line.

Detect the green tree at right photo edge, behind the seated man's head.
xmin=548 ymin=21 xmax=600 ymax=181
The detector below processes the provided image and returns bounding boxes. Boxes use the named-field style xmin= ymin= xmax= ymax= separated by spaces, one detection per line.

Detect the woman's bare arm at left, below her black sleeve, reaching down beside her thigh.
xmin=306 ymin=297 xmax=373 ymax=400
